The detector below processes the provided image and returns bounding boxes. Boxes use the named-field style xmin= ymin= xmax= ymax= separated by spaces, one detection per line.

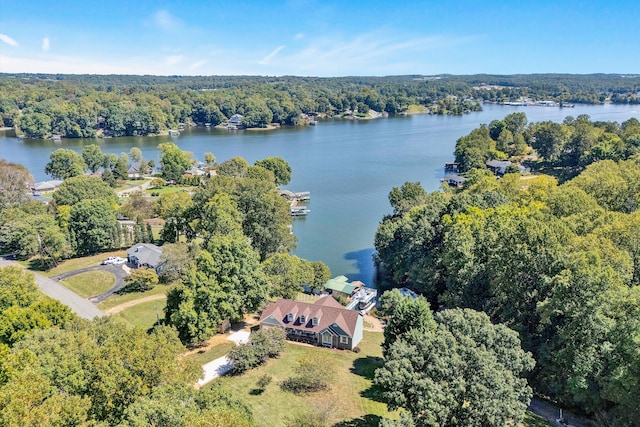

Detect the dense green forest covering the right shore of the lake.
xmin=375 ymin=115 xmax=640 ymax=425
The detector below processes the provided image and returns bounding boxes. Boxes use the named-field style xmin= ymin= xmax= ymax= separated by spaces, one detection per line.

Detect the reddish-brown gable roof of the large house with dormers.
xmin=260 ymin=295 xmax=360 ymax=337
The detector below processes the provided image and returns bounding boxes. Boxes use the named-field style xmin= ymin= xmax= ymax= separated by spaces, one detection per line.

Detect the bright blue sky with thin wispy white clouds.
xmin=0 ymin=0 xmax=640 ymax=76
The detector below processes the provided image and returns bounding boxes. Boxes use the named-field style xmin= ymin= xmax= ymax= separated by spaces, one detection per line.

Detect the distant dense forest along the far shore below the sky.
xmin=0 ymin=74 xmax=640 ymax=138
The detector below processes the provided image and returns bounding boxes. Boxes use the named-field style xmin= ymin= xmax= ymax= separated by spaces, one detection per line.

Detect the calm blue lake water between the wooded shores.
xmin=0 ymin=105 xmax=640 ymax=284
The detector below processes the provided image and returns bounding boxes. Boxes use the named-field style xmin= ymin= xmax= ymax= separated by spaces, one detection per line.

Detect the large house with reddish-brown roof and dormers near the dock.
xmin=260 ymin=295 xmax=364 ymax=350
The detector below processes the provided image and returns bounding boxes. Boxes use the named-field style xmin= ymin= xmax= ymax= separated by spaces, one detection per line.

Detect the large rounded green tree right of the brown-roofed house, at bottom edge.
xmin=375 ymin=309 xmax=534 ymax=426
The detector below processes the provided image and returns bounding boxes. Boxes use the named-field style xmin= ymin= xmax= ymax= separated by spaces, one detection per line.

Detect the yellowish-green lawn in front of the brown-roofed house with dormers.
xmin=216 ymin=332 xmax=398 ymax=427
